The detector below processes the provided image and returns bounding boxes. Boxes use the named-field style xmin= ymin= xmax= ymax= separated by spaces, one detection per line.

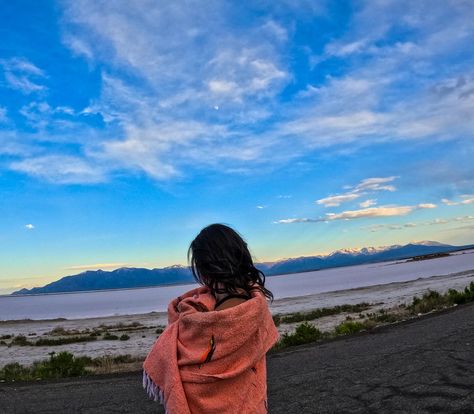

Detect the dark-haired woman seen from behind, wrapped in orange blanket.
xmin=143 ymin=224 xmax=278 ymax=414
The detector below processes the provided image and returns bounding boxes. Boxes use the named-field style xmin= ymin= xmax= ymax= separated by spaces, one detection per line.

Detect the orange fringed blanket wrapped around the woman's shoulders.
xmin=143 ymin=287 xmax=278 ymax=414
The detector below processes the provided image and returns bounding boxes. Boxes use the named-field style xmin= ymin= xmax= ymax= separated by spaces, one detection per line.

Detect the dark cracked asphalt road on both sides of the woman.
xmin=0 ymin=304 xmax=474 ymax=414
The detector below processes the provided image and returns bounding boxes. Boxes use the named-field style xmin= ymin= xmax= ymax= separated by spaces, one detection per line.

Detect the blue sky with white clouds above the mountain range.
xmin=0 ymin=0 xmax=474 ymax=293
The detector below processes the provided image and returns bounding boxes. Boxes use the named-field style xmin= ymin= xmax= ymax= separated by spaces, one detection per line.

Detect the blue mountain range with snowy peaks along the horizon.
xmin=12 ymin=241 xmax=474 ymax=295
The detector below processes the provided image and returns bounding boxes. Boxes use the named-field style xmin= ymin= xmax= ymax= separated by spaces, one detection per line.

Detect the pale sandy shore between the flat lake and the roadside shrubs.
xmin=0 ymin=269 xmax=474 ymax=367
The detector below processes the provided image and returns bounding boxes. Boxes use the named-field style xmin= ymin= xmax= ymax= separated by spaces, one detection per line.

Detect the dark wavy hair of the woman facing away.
xmin=188 ymin=224 xmax=273 ymax=300
